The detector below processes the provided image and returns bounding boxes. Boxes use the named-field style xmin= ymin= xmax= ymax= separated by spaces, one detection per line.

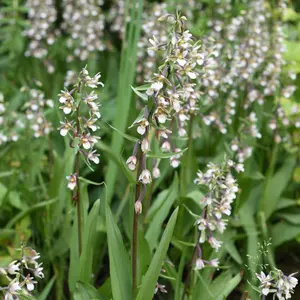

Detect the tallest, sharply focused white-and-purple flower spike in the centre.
xmin=127 ymin=14 xmax=213 ymax=211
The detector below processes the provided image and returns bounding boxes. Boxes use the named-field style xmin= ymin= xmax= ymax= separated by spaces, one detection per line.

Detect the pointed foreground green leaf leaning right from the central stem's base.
xmin=137 ymin=207 xmax=178 ymax=300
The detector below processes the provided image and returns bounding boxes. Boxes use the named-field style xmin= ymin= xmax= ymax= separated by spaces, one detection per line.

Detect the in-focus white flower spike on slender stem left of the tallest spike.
xmin=58 ymin=69 xmax=103 ymax=190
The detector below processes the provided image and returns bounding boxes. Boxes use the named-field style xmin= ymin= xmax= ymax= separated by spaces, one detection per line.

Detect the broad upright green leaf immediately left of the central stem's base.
xmin=106 ymin=205 xmax=133 ymax=300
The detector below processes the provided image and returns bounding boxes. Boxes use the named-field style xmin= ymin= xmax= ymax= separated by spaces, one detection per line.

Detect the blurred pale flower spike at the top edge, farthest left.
xmin=24 ymin=0 xmax=59 ymax=67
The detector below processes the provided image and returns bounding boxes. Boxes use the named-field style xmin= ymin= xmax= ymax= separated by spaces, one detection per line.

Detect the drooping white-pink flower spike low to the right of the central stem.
xmin=195 ymin=160 xmax=244 ymax=269
